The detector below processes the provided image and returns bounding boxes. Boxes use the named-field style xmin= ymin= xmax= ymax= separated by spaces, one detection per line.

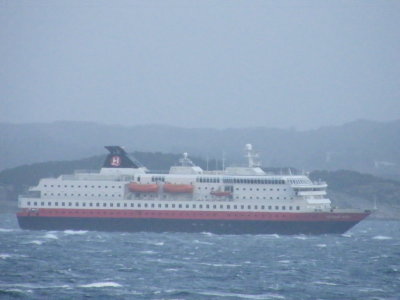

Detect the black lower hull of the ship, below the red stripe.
xmin=18 ymin=216 xmax=361 ymax=235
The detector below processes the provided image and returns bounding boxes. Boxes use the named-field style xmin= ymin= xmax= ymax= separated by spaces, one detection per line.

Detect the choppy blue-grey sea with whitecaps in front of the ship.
xmin=0 ymin=214 xmax=400 ymax=299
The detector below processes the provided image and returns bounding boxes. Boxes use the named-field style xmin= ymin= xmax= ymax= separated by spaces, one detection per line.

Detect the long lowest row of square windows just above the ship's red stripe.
xmin=27 ymin=201 xmax=300 ymax=210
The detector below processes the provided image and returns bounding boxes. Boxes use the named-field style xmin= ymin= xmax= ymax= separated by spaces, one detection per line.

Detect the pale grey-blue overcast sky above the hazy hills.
xmin=0 ymin=0 xmax=400 ymax=129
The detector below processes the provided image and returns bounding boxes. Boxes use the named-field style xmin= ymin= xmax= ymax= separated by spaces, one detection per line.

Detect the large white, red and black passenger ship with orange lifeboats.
xmin=17 ymin=144 xmax=370 ymax=234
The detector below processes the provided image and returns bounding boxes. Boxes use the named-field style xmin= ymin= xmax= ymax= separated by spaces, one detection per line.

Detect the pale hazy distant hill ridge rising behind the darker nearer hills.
xmin=0 ymin=120 xmax=400 ymax=178
